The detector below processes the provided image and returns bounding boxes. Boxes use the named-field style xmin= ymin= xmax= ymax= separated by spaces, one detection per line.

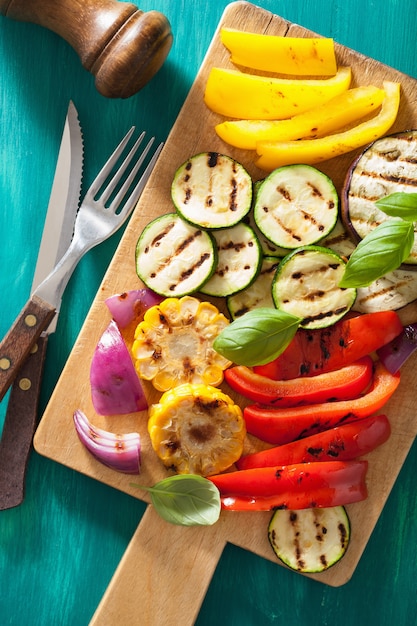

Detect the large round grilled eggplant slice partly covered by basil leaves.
xmin=341 ymin=130 xmax=417 ymax=264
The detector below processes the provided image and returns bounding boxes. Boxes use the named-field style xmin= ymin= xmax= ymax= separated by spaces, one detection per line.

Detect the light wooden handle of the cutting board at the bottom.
xmin=89 ymin=505 xmax=226 ymax=626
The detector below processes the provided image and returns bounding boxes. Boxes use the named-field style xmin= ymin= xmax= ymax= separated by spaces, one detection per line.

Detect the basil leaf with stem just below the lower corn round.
xmin=132 ymin=474 xmax=221 ymax=526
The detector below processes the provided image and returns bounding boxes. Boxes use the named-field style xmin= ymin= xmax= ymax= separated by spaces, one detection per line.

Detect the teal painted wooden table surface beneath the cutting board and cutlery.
xmin=0 ymin=0 xmax=417 ymax=626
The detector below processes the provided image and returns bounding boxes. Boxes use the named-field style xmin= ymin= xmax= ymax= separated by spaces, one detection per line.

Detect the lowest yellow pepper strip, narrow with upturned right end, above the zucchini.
xmin=256 ymin=81 xmax=401 ymax=171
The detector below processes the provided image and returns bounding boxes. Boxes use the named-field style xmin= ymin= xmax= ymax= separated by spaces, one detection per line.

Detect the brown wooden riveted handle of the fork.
xmin=0 ymin=295 xmax=55 ymax=400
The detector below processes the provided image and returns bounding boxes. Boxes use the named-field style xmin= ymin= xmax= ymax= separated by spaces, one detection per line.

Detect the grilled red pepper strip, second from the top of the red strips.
xmin=225 ymin=356 xmax=373 ymax=407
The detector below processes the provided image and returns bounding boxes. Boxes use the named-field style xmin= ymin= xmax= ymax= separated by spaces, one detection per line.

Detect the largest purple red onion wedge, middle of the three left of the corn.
xmin=90 ymin=320 xmax=148 ymax=415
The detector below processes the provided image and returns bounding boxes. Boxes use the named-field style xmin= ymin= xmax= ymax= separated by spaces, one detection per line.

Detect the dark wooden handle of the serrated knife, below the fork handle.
xmin=0 ymin=335 xmax=48 ymax=511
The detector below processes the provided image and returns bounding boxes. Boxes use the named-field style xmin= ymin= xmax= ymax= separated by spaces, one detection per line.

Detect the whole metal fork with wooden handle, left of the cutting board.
xmin=0 ymin=127 xmax=163 ymax=400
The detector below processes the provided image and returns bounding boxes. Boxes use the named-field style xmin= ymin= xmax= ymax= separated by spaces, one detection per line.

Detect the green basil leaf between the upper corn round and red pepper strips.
xmin=213 ymin=307 xmax=301 ymax=367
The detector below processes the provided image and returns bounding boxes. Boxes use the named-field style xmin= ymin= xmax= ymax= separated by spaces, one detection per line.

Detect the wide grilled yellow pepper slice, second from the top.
xmin=204 ymin=67 xmax=352 ymax=120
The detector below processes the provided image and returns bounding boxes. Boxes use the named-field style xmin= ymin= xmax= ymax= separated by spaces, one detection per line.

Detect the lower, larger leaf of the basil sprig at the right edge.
xmin=339 ymin=219 xmax=414 ymax=288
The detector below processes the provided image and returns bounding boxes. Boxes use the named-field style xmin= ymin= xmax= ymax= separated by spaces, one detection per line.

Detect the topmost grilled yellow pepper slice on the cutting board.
xmin=220 ymin=28 xmax=337 ymax=76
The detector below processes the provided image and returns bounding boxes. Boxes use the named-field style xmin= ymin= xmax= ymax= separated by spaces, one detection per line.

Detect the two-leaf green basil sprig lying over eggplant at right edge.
xmin=339 ymin=192 xmax=417 ymax=288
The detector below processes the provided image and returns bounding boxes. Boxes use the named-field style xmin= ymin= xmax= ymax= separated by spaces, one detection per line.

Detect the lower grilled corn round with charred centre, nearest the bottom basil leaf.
xmin=148 ymin=383 xmax=246 ymax=476
